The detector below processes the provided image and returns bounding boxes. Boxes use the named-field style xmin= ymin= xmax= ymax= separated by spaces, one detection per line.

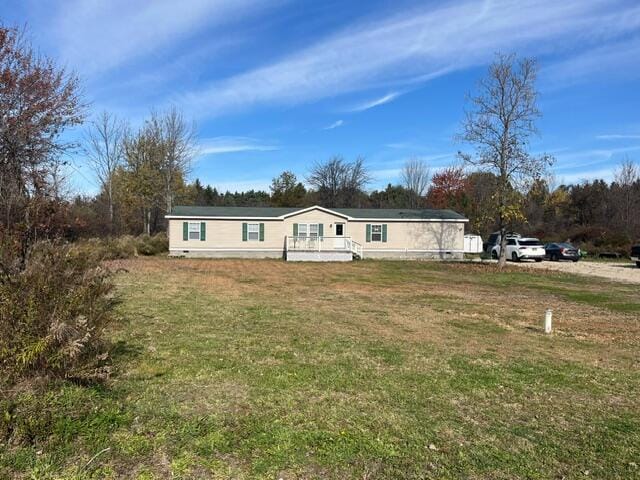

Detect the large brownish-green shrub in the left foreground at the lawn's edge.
xmin=0 ymin=242 xmax=114 ymax=383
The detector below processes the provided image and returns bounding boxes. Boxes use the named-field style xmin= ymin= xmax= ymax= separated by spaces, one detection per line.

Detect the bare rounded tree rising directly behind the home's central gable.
xmin=307 ymin=157 xmax=371 ymax=207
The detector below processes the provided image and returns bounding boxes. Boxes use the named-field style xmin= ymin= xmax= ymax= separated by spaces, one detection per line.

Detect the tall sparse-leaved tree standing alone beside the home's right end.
xmin=460 ymin=54 xmax=553 ymax=268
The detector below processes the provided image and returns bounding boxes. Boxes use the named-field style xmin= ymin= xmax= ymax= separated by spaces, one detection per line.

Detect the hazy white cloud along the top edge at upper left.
xmin=47 ymin=0 xmax=273 ymax=75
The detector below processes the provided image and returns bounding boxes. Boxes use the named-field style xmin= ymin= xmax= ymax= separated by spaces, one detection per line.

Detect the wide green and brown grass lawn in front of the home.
xmin=0 ymin=258 xmax=640 ymax=479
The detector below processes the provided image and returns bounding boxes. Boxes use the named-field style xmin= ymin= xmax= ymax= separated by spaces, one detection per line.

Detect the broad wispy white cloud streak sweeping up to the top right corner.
xmin=174 ymin=0 xmax=640 ymax=116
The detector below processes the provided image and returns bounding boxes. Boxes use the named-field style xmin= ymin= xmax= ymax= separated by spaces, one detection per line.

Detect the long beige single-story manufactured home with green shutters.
xmin=166 ymin=206 xmax=468 ymax=261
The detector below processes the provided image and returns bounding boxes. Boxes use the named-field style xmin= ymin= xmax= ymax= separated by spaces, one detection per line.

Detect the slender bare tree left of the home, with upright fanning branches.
xmin=85 ymin=111 xmax=127 ymax=233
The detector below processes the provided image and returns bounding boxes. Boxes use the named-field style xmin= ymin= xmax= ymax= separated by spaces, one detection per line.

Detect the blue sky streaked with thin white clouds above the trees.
xmin=0 ymin=0 xmax=640 ymax=193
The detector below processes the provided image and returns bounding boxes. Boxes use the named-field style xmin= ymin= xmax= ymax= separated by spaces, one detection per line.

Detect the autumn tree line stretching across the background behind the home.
xmin=71 ymin=150 xmax=640 ymax=252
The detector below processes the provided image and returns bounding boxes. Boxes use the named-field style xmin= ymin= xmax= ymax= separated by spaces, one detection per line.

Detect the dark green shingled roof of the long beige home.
xmin=171 ymin=206 xmax=466 ymax=220
